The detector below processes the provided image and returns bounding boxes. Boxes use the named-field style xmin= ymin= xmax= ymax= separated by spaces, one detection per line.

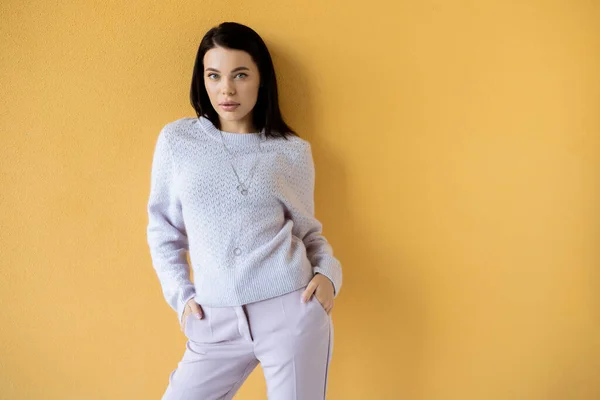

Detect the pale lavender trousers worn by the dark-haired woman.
xmin=162 ymin=288 xmax=333 ymax=400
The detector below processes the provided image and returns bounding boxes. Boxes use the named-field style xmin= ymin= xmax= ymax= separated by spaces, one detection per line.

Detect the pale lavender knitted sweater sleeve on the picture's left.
xmin=146 ymin=126 xmax=195 ymax=322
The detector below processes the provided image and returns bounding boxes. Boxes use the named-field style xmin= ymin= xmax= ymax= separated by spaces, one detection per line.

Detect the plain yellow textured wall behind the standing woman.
xmin=0 ymin=0 xmax=600 ymax=400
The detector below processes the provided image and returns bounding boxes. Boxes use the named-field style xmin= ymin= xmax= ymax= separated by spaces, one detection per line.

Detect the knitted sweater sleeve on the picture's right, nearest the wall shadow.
xmin=289 ymin=142 xmax=342 ymax=297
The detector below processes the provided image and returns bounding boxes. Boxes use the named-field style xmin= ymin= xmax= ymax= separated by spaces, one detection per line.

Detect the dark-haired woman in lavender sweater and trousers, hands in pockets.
xmin=147 ymin=22 xmax=342 ymax=400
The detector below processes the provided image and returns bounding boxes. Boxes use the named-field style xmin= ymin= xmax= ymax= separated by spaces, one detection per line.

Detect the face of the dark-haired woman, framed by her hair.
xmin=204 ymin=46 xmax=260 ymax=130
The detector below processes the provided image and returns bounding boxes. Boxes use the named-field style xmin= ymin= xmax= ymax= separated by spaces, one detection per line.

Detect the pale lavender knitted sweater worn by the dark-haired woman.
xmin=146 ymin=117 xmax=342 ymax=320
